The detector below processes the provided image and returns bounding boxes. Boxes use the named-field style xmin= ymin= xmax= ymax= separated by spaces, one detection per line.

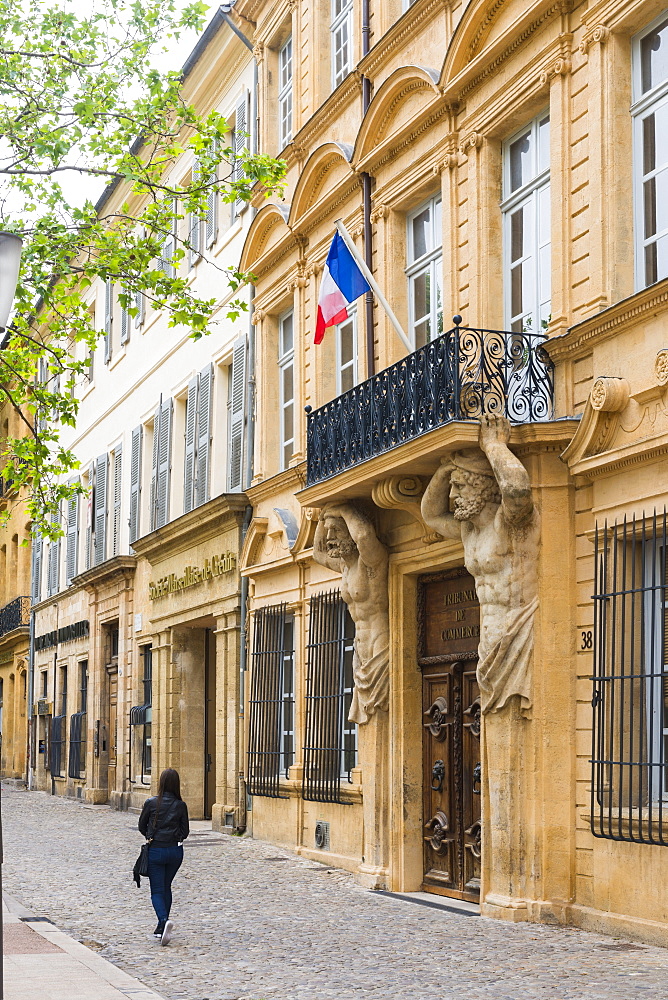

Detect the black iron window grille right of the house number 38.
xmin=583 ymin=510 xmax=668 ymax=844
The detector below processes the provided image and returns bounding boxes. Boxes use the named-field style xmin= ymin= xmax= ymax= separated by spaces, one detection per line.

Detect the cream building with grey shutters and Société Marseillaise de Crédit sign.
xmin=31 ymin=8 xmax=255 ymax=828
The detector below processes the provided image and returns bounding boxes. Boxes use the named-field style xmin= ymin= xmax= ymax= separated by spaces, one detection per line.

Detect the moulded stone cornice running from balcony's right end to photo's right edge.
xmin=545 ymin=278 xmax=668 ymax=362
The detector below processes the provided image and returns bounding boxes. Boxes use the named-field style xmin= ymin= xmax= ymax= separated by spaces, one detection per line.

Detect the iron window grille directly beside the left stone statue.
xmin=302 ymin=591 xmax=357 ymax=802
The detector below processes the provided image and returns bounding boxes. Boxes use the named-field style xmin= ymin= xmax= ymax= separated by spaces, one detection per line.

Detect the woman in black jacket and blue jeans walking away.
xmin=138 ymin=767 xmax=190 ymax=945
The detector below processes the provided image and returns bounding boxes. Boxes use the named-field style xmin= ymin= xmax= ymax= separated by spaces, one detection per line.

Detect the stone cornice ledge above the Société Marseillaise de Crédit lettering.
xmin=133 ymin=493 xmax=248 ymax=565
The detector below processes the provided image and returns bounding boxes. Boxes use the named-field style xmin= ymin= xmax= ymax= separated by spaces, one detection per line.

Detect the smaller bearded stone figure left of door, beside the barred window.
xmin=313 ymin=504 xmax=390 ymax=725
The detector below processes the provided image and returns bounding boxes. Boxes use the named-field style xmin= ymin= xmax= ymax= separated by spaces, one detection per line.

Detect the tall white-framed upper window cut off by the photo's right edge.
xmin=632 ymin=14 xmax=668 ymax=288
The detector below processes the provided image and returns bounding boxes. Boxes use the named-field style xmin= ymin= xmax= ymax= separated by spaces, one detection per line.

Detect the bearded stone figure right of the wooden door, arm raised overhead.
xmin=422 ymin=414 xmax=540 ymax=714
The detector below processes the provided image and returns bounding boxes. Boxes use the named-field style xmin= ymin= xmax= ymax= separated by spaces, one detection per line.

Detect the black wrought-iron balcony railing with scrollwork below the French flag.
xmin=306 ymin=316 xmax=554 ymax=486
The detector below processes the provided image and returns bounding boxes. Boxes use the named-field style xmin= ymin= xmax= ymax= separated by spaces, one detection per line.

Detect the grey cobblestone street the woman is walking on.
xmin=2 ymin=786 xmax=668 ymax=1000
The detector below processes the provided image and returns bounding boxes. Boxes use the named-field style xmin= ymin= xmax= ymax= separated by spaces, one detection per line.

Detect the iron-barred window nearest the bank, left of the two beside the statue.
xmin=248 ymin=604 xmax=295 ymax=798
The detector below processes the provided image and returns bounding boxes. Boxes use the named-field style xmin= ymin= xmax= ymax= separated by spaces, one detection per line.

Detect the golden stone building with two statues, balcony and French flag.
xmin=236 ymin=0 xmax=668 ymax=943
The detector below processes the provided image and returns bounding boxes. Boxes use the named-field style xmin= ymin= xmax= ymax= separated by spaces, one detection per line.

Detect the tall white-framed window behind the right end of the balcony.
xmin=501 ymin=114 xmax=551 ymax=333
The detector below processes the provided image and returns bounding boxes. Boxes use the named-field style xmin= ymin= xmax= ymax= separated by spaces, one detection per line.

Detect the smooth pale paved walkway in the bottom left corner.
xmin=2 ymin=895 xmax=167 ymax=1000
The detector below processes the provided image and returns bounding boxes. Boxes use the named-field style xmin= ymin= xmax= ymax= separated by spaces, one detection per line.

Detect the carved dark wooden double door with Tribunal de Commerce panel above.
xmin=419 ymin=569 xmax=481 ymax=902
